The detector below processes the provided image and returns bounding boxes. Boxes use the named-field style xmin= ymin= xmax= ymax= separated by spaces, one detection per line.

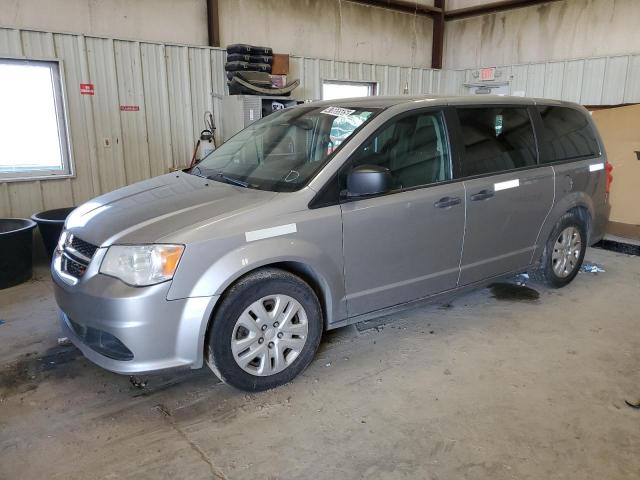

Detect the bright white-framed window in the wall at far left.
xmin=0 ymin=58 xmax=72 ymax=182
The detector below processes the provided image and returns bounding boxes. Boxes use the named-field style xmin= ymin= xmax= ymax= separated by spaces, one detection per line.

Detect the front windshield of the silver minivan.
xmin=191 ymin=106 xmax=375 ymax=192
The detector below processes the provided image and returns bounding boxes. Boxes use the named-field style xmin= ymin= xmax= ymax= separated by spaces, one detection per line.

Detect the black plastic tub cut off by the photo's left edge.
xmin=0 ymin=218 xmax=36 ymax=290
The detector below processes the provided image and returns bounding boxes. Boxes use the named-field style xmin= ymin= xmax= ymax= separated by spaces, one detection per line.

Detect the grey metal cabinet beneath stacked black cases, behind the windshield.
xmin=222 ymin=95 xmax=302 ymax=142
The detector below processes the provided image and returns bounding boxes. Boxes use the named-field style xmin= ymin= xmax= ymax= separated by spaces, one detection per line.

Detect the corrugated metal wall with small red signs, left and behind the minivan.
xmin=0 ymin=28 xmax=462 ymax=217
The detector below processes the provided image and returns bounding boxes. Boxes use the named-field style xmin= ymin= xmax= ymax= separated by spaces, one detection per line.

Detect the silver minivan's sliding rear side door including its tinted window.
xmin=457 ymin=106 xmax=554 ymax=285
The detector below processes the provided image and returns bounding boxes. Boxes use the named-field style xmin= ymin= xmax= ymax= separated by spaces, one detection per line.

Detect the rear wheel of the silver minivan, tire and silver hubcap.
xmin=531 ymin=213 xmax=587 ymax=288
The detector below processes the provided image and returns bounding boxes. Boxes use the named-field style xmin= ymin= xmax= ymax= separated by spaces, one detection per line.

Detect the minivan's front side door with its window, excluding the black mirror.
xmin=341 ymin=109 xmax=465 ymax=316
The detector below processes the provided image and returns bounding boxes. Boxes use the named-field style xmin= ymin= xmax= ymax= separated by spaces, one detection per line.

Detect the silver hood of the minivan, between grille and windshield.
xmin=66 ymin=172 xmax=277 ymax=247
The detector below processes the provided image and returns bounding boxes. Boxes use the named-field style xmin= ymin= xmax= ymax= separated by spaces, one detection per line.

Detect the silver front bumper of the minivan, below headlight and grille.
xmin=52 ymin=249 xmax=219 ymax=374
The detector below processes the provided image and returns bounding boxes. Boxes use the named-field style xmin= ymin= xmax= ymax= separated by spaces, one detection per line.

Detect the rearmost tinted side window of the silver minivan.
xmin=538 ymin=106 xmax=600 ymax=163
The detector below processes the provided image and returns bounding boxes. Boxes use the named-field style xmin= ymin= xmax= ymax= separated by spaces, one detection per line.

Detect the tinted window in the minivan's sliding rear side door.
xmin=458 ymin=107 xmax=537 ymax=177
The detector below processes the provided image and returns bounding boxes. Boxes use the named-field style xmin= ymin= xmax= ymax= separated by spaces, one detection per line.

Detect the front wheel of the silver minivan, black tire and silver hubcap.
xmin=207 ymin=268 xmax=323 ymax=392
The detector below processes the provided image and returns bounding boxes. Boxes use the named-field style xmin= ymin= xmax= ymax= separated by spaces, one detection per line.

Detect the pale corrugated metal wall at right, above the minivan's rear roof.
xmin=464 ymin=55 xmax=640 ymax=105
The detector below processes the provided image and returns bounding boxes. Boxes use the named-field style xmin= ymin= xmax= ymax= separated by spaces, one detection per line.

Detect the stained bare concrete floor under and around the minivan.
xmin=0 ymin=250 xmax=640 ymax=480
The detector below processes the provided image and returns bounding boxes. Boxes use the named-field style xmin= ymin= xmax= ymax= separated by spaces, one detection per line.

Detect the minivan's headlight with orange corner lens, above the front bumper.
xmin=100 ymin=245 xmax=184 ymax=287
